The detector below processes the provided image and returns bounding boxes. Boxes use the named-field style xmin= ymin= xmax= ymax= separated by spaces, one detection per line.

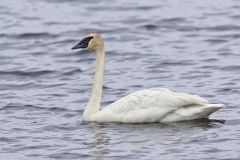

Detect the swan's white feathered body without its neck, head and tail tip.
xmin=92 ymin=88 xmax=221 ymax=123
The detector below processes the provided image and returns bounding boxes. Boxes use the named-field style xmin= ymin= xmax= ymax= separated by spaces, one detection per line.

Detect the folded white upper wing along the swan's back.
xmin=106 ymin=88 xmax=208 ymax=113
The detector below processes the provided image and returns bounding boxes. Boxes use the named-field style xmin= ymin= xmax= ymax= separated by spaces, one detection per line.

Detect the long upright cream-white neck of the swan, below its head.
xmin=83 ymin=48 xmax=105 ymax=120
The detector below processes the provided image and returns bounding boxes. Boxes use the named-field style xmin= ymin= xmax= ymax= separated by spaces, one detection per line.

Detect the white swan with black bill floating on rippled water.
xmin=72 ymin=32 xmax=224 ymax=123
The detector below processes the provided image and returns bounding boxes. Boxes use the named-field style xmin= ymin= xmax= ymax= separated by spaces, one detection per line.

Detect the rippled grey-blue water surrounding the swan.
xmin=0 ymin=0 xmax=240 ymax=160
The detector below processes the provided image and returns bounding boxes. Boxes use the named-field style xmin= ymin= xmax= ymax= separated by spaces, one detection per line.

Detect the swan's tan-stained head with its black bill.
xmin=72 ymin=32 xmax=104 ymax=51
